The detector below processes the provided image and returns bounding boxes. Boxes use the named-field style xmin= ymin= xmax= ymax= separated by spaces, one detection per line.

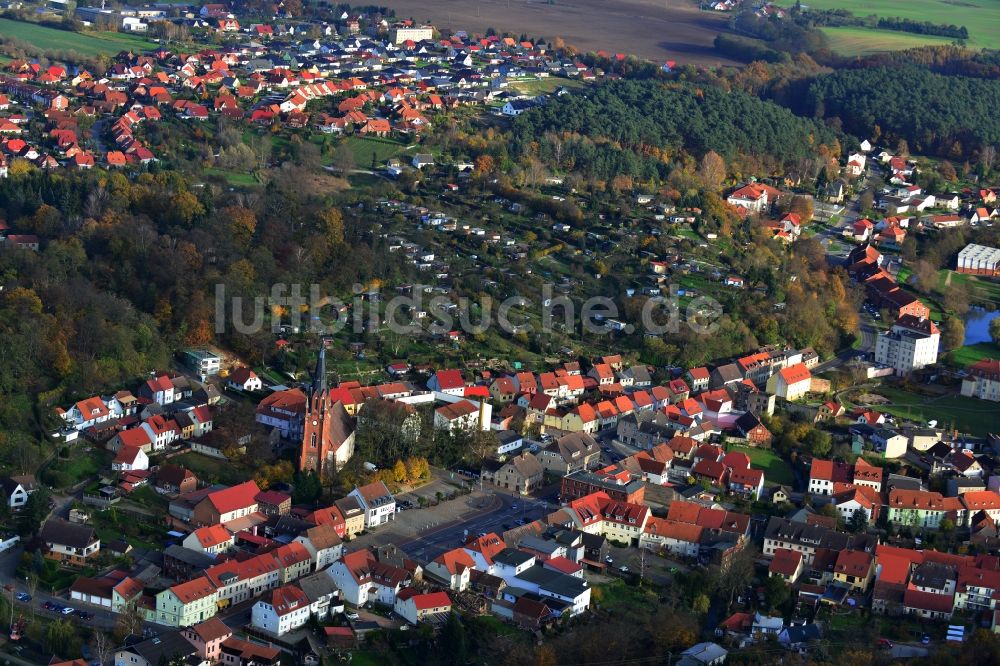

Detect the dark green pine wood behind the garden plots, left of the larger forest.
xmin=510 ymin=81 xmax=838 ymax=180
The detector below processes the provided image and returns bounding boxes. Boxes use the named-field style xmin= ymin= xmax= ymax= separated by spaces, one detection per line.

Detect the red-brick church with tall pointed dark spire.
xmin=299 ymin=342 xmax=354 ymax=476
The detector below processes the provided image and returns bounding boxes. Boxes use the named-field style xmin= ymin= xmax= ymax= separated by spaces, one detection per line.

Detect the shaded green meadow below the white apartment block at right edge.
xmin=872 ymin=386 xmax=997 ymax=437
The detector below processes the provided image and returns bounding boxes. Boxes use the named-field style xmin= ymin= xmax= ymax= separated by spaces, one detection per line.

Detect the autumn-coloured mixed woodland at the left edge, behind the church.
xmin=0 ymin=166 xmax=395 ymax=469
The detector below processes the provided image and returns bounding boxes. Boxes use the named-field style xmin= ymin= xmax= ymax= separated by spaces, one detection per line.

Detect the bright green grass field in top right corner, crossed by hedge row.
xmin=803 ymin=0 xmax=1000 ymax=55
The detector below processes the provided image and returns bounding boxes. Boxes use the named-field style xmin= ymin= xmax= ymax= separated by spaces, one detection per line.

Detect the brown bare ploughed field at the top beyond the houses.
xmin=383 ymin=0 xmax=739 ymax=65
